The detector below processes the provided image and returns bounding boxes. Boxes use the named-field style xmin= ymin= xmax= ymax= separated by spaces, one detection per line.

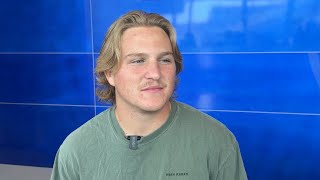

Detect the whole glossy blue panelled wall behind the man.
xmin=0 ymin=0 xmax=320 ymax=180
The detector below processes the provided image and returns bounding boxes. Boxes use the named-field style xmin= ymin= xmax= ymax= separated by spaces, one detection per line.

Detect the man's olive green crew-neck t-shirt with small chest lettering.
xmin=51 ymin=101 xmax=247 ymax=180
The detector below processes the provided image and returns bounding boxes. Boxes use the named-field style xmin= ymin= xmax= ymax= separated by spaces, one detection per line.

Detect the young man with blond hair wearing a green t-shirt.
xmin=51 ymin=11 xmax=247 ymax=180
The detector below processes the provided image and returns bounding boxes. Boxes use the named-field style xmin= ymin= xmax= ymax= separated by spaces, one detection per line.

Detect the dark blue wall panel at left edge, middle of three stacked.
xmin=0 ymin=54 xmax=94 ymax=104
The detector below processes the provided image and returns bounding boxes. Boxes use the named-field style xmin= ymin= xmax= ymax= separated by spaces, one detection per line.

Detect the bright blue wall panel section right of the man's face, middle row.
xmin=177 ymin=53 xmax=320 ymax=113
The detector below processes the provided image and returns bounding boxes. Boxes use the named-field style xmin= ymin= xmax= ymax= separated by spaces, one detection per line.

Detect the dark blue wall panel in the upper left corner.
xmin=0 ymin=0 xmax=91 ymax=52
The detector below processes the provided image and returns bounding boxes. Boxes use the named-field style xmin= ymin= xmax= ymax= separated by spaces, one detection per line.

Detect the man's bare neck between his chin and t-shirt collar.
xmin=115 ymin=102 xmax=171 ymax=136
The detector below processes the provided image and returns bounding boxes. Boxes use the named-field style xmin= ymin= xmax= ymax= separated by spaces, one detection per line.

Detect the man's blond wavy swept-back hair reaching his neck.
xmin=95 ymin=11 xmax=182 ymax=104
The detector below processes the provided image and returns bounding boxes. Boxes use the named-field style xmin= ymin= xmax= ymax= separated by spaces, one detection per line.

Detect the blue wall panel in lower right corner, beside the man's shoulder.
xmin=202 ymin=112 xmax=320 ymax=180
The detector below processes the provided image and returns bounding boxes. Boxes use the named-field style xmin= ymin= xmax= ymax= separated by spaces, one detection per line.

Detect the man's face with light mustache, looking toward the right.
xmin=106 ymin=27 xmax=176 ymax=112
